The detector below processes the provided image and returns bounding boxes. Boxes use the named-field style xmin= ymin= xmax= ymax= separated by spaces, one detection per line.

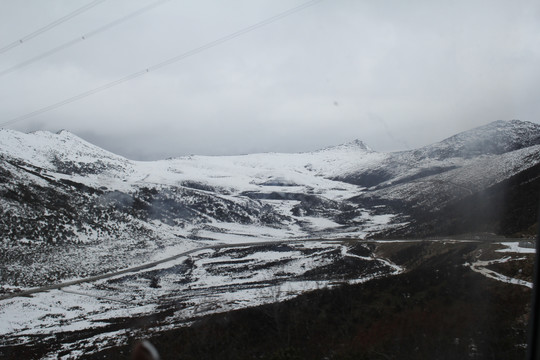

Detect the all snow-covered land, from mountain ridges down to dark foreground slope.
xmin=0 ymin=120 xmax=540 ymax=358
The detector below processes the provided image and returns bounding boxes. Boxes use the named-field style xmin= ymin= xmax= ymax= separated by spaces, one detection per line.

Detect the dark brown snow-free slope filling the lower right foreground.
xmin=88 ymin=242 xmax=533 ymax=360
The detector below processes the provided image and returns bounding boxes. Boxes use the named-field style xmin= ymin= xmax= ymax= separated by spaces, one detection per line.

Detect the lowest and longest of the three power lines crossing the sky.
xmin=0 ymin=0 xmax=323 ymax=127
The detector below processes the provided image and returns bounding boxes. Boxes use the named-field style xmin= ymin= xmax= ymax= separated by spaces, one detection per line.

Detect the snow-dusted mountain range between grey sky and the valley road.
xmin=0 ymin=120 xmax=540 ymax=284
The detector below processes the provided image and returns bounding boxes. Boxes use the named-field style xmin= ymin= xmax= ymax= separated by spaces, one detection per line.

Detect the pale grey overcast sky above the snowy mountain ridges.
xmin=0 ymin=0 xmax=540 ymax=160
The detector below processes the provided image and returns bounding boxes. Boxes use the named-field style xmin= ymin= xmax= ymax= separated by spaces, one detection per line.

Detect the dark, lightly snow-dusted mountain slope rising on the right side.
xmin=343 ymin=120 xmax=540 ymax=237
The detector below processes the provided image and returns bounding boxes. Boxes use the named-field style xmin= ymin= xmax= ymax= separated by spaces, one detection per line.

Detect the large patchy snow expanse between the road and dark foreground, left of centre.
xmin=0 ymin=241 xmax=403 ymax=356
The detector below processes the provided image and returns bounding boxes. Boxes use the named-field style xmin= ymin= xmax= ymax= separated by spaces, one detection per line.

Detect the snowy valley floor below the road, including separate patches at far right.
xmin=0 ymin=240 xmax=533 ymax=358
